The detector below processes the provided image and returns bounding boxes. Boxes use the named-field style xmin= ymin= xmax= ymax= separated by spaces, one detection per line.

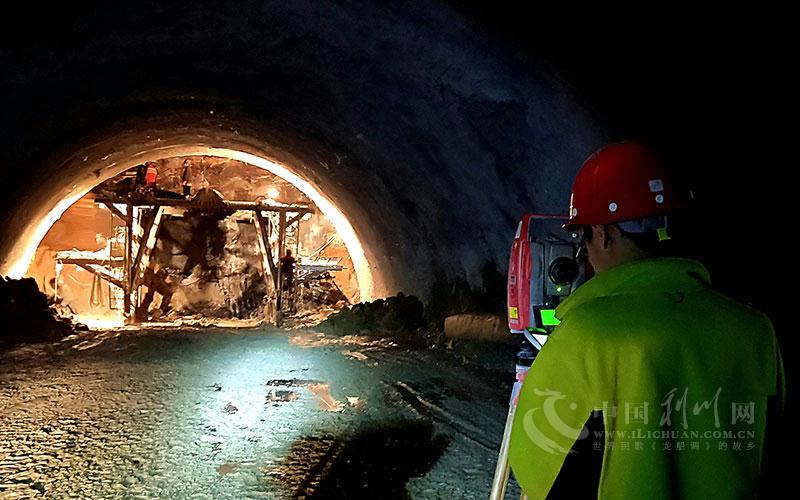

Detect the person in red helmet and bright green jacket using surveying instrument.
xmin=509 ymin=142 xmax=784 ymax=499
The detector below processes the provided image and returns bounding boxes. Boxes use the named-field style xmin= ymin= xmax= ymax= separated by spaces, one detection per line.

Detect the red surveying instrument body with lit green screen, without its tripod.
xmin=508 ymin=214 xmax=584 ymax=345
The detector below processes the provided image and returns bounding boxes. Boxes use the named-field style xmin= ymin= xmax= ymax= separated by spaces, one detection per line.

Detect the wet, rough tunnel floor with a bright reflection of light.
xmin=0 ymin=330 xmax=518 ymax=499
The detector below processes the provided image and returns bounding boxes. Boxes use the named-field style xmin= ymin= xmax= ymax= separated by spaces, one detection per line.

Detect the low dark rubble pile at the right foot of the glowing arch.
xmin=317 ymin=292 xmax=427 ymax=336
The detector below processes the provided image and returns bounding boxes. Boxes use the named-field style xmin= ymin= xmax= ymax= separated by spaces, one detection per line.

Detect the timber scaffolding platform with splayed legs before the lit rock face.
xmin=56 ymin=189 xmax=343 ymax=324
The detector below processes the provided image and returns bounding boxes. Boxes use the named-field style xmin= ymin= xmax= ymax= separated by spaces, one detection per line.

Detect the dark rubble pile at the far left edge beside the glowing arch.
xmin=0 ymin=276 xmax=72 ymax=349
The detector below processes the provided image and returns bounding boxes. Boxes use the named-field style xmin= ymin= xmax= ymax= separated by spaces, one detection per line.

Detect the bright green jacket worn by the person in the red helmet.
xmin=509 ymin=258 xmax=783 ymax=499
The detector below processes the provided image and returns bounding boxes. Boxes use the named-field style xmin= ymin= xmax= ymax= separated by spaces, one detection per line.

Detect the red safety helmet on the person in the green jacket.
xmin=564 ymin=142 xmax=690 ymax=230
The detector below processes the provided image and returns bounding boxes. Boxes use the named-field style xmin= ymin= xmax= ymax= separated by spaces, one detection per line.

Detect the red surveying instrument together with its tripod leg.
xmin=489 ymin=214 xmax=585 ymax=500
